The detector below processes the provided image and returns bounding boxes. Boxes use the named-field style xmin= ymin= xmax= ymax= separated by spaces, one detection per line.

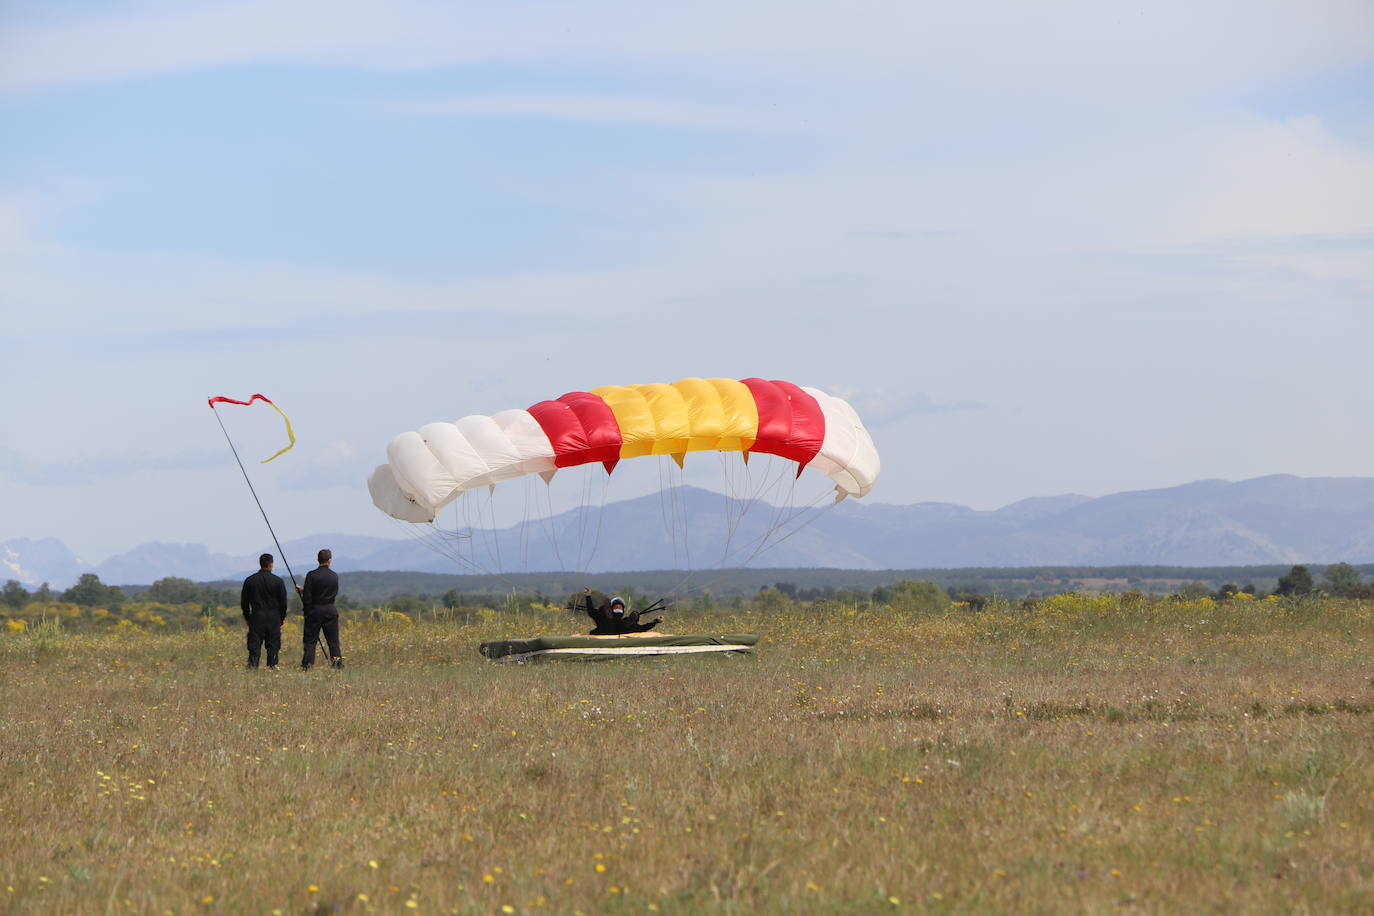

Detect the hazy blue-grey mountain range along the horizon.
xmin=0 ymin=475 xmax=1374 ymax=588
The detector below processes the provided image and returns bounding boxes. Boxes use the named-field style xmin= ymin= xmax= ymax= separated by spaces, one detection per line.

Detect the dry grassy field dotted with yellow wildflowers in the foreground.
xmin=0 ymin=596 xmax=1374 ymax=913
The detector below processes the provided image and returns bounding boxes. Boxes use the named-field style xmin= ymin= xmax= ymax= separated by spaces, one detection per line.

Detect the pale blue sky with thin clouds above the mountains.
xmin=0 ymin=0 xmax=1374 ymax=560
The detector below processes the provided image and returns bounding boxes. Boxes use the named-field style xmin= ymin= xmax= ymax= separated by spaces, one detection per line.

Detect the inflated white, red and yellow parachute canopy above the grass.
xmin=367 ymin=379 xmax=881 ymax=522
